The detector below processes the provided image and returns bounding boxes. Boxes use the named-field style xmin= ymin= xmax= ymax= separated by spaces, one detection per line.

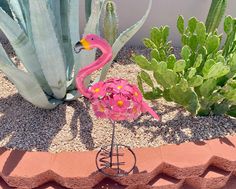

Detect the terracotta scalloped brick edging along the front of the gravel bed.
xmin=0 ymin=136 xmax=236 ymax=189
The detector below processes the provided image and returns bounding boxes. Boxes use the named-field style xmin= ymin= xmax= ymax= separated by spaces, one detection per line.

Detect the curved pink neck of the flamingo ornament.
xmin=76 ymin=39 xmax=112 ymax=98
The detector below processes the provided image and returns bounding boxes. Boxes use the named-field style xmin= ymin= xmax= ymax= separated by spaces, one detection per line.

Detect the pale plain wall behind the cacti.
xmin=81 ymin=0 xmax=236 ymax=46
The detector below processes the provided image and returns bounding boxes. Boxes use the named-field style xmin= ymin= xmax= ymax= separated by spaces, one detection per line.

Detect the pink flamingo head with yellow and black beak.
xmin=74 ymin=34 xmax=109 ymax=53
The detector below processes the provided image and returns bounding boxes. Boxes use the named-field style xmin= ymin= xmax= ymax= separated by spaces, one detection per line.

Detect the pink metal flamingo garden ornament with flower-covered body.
xmin=74 ymin=34 xmax=160 ymax=175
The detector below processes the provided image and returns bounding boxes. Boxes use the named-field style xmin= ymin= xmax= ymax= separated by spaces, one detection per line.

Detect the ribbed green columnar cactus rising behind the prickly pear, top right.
xmin=205 ymin=0 xmax=227 ymax=33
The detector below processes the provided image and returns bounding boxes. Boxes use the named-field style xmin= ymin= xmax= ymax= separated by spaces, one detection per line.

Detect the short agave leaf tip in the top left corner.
xmin=8 ymin=0 xmax=27 ymax=31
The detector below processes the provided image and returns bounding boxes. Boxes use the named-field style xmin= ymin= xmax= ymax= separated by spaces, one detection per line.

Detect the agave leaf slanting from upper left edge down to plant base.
xmin=0 ymin=9 xmax=52 ymax=95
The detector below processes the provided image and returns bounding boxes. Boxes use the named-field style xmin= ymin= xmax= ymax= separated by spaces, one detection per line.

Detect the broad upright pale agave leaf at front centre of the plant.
xmin=29 ymin=1 xmax=66 ymax=99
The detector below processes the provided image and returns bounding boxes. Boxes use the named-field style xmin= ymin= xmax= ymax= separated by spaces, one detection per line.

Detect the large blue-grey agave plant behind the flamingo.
xmin=0 ymin=0 xmax=152 ymax=109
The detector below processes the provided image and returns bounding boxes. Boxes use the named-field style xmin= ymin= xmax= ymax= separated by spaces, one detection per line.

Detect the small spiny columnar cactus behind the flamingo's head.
xmin=103 ymin=1 xmax=118 ymax=45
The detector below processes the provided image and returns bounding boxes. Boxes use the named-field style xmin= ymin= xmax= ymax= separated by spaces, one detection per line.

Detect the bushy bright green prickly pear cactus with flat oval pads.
xmin=132 ymin=16 xmax=236 ymax=116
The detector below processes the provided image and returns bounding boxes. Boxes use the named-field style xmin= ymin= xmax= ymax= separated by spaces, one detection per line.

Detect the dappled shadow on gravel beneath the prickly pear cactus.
xmin=120 ymin=102 xmax=236 ymax=147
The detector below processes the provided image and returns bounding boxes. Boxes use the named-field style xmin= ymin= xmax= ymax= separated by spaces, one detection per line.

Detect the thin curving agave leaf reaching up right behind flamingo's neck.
xmin=99 ymin=0 xmax=152 ymax=81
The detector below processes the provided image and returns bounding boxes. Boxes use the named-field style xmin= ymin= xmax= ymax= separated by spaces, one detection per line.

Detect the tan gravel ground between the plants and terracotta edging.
xmin=0 ymin=38 xmax=236 ymax=152
